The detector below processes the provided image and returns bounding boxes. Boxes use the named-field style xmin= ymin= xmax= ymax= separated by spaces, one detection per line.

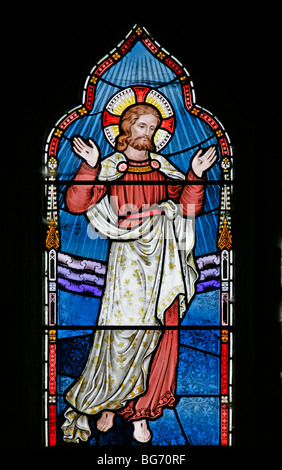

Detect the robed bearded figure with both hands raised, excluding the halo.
xmin=62 ymin=104 xmax=217 ymax=443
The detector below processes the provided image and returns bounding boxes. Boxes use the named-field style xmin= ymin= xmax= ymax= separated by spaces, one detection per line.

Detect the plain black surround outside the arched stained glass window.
xmin=4 ymin=2 xmax=282 ymax=463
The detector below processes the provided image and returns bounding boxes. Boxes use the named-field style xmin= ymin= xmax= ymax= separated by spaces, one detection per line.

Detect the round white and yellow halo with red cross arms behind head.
xmin=102 ymin=85 xmax=175 ymax=151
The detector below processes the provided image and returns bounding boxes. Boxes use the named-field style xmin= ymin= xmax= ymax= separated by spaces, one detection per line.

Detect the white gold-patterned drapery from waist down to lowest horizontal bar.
xmin=87 ymin=195 xmax=197 ymax=326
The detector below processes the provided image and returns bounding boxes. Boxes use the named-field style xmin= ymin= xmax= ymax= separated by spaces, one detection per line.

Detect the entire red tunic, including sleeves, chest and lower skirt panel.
xmin=66 ymin=160 xmax=204 ymax=420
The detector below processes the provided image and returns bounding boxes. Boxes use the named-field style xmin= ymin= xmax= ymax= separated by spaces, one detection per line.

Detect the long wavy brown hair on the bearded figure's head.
xmin=116 ymin=104 xmax=162 ymax=152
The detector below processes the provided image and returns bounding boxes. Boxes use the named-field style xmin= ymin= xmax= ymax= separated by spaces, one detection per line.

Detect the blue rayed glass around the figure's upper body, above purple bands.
xmin=58 ymin=42 xmax=221 ymax=259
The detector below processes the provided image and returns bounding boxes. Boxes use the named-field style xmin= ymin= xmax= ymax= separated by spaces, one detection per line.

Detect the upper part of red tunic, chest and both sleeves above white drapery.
xmin=66 ymin=160 xmax=204 ymax=216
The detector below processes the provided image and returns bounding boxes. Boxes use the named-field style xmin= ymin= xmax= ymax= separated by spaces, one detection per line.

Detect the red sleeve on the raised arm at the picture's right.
xmin=168 ymin=169 xmax=205 ymax=217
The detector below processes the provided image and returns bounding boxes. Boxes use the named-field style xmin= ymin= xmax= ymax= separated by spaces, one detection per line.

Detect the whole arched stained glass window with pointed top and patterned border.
xmin=44 ymin=26 xmax=234 ymax=447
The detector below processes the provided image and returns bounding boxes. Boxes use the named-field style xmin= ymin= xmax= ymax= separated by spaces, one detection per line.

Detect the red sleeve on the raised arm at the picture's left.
xmin=66 ymin=162 xmax=107 ymax=214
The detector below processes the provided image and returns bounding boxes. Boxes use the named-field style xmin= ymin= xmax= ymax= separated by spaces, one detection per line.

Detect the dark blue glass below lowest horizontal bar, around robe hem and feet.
xmin=57 ymin=329 xmax=220 ymax=445
